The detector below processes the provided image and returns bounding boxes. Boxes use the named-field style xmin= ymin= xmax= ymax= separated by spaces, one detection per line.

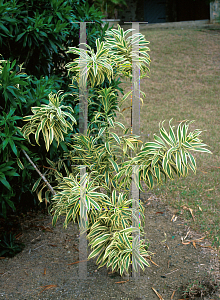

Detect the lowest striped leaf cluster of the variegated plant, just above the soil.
xmin=88 ymin=190 xmax=149 ymax=275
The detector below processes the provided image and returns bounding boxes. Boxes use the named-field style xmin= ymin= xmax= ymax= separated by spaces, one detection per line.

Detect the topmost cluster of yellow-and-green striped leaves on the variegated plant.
xmin=66 ymin=25 xmax=150 ymax=87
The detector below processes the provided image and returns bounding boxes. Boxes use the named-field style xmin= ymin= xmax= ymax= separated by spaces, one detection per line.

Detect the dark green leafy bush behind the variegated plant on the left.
xmin=0 ymin=0 xmax=106 ymax=218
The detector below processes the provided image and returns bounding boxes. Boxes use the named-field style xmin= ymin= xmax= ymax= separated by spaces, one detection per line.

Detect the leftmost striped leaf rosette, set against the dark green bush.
xmin=21 ymin=91 xmax=76 ymax=151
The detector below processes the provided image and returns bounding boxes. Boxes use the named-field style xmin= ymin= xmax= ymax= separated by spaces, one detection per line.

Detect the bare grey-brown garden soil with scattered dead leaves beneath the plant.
xmin=0 ymin=193 xmax=220 ymax=300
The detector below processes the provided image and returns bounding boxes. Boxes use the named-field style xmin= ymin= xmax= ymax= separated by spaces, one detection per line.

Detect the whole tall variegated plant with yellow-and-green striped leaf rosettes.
xmin=20 ymin=26 xmax=211 ymax=275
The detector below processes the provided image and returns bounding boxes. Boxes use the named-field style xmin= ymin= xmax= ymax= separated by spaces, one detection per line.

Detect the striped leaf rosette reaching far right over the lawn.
xmin=116 ymin=121 xmax=212 ymax=190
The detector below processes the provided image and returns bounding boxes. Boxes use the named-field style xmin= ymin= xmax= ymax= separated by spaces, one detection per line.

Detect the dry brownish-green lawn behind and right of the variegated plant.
xmin=117 ymin=29 xmax=220 ymax=247
